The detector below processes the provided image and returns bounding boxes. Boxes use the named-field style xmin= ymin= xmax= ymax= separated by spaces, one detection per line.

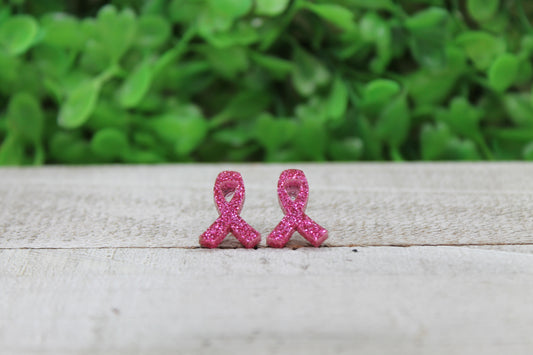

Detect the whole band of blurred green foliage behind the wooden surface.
xmin=0 ymin=0 xmax=533 ymax=165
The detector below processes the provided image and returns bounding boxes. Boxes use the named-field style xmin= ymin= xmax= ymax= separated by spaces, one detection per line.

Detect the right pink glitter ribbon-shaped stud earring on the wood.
xmin=267 ymin=169 xmax=328 ymax=248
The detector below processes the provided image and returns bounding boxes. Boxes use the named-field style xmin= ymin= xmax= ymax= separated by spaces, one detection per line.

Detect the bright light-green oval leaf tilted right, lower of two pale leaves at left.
xmin=58 ymin=80 xmax=100 ymax=129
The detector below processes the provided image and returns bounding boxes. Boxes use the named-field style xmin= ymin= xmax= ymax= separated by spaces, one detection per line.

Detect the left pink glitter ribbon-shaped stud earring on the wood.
xmin=200 ymin=171 xmax=261 ymax=248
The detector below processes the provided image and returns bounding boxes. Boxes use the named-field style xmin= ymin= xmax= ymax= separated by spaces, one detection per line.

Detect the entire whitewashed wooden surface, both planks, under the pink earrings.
xmin=0 ymin=163 xmax=533 ymax=354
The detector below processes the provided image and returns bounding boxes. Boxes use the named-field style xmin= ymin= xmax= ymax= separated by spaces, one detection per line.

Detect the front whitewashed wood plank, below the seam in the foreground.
xmin=0 ymin=247 xmax=533 ymax=354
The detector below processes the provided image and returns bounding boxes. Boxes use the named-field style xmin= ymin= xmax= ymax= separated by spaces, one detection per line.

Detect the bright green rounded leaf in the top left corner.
xmin=0 ymin=15 xmax=39 ymax=55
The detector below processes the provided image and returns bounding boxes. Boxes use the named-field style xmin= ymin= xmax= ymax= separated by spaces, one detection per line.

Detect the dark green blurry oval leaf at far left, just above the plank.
xmin=7 ymin=93 xmax=44 ymax=144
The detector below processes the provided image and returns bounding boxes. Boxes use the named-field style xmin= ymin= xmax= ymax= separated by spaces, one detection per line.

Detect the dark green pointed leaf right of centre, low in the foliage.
xmin=376 ymin=95 xmax=410 ymax=148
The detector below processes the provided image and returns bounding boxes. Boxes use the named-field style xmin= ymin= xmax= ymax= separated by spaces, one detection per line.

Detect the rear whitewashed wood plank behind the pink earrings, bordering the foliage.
xmin=0 ymin=163 xmax=533 ymax=248
